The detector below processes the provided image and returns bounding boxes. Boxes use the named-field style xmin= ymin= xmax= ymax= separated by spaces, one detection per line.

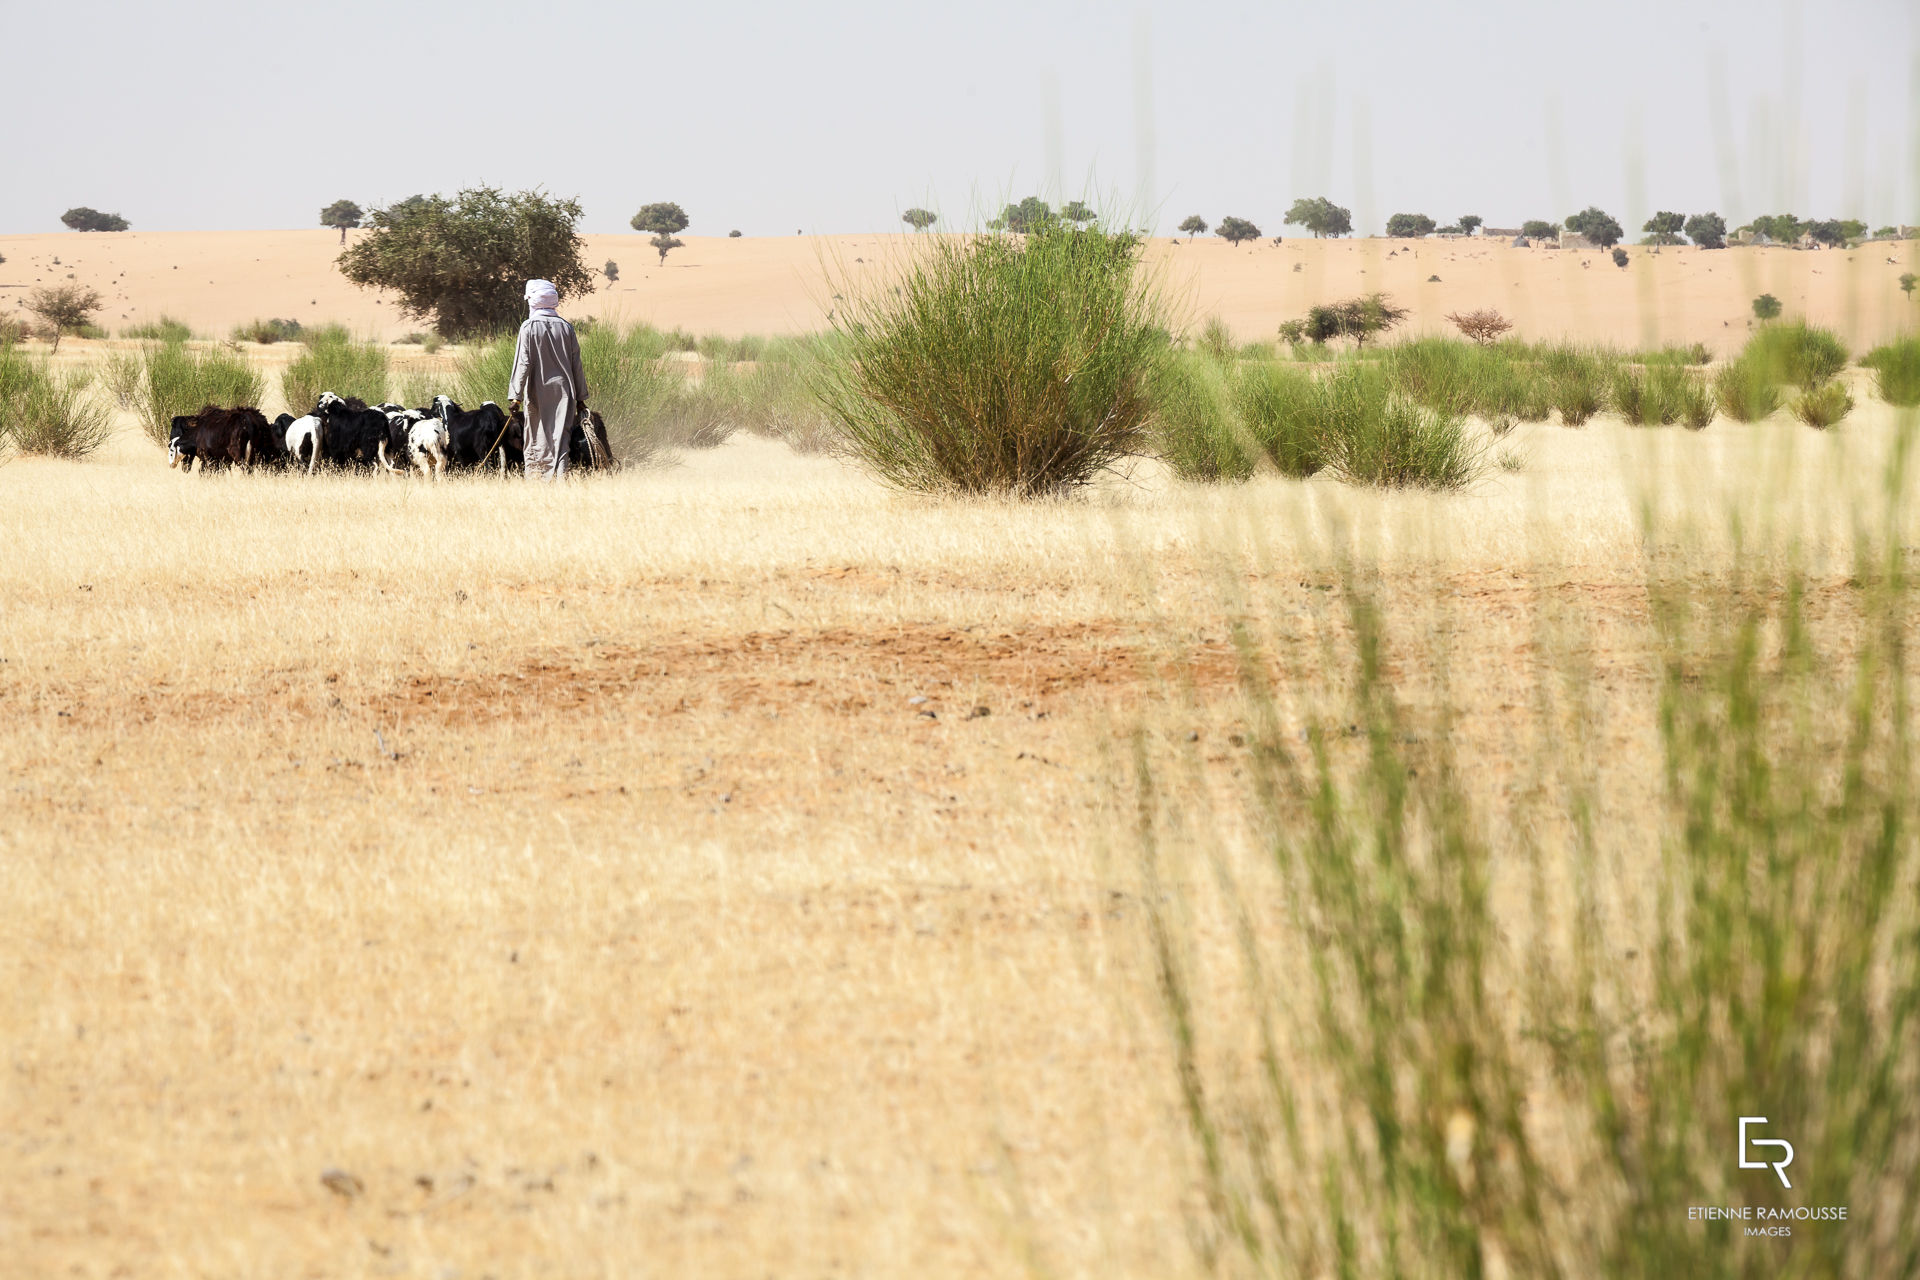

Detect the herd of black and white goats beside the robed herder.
xmin=167 ymin=391 xmax=612 ymax=480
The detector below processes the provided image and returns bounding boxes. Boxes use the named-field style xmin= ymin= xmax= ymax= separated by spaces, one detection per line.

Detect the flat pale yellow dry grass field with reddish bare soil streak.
xmin=0 ymin=351 xmax=1920 ymax=1280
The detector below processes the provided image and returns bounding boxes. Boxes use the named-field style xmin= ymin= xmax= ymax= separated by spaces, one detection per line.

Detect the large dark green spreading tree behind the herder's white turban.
xmin=336 ymin=186 xmax=593 ymax=338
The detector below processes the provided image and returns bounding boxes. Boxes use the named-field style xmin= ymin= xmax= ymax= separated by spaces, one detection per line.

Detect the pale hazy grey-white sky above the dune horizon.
xmin=0 ymin=0 xmax=1920 ymax=236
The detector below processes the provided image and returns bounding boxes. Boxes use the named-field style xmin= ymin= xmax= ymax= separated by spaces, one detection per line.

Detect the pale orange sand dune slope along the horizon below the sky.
xmin=0 ymin=228 xmax=1920 ymax=353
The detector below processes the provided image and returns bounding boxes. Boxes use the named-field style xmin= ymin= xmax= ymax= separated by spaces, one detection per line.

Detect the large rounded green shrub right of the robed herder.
xmin=818 ymin=220 xmax=1165 ymax=497
